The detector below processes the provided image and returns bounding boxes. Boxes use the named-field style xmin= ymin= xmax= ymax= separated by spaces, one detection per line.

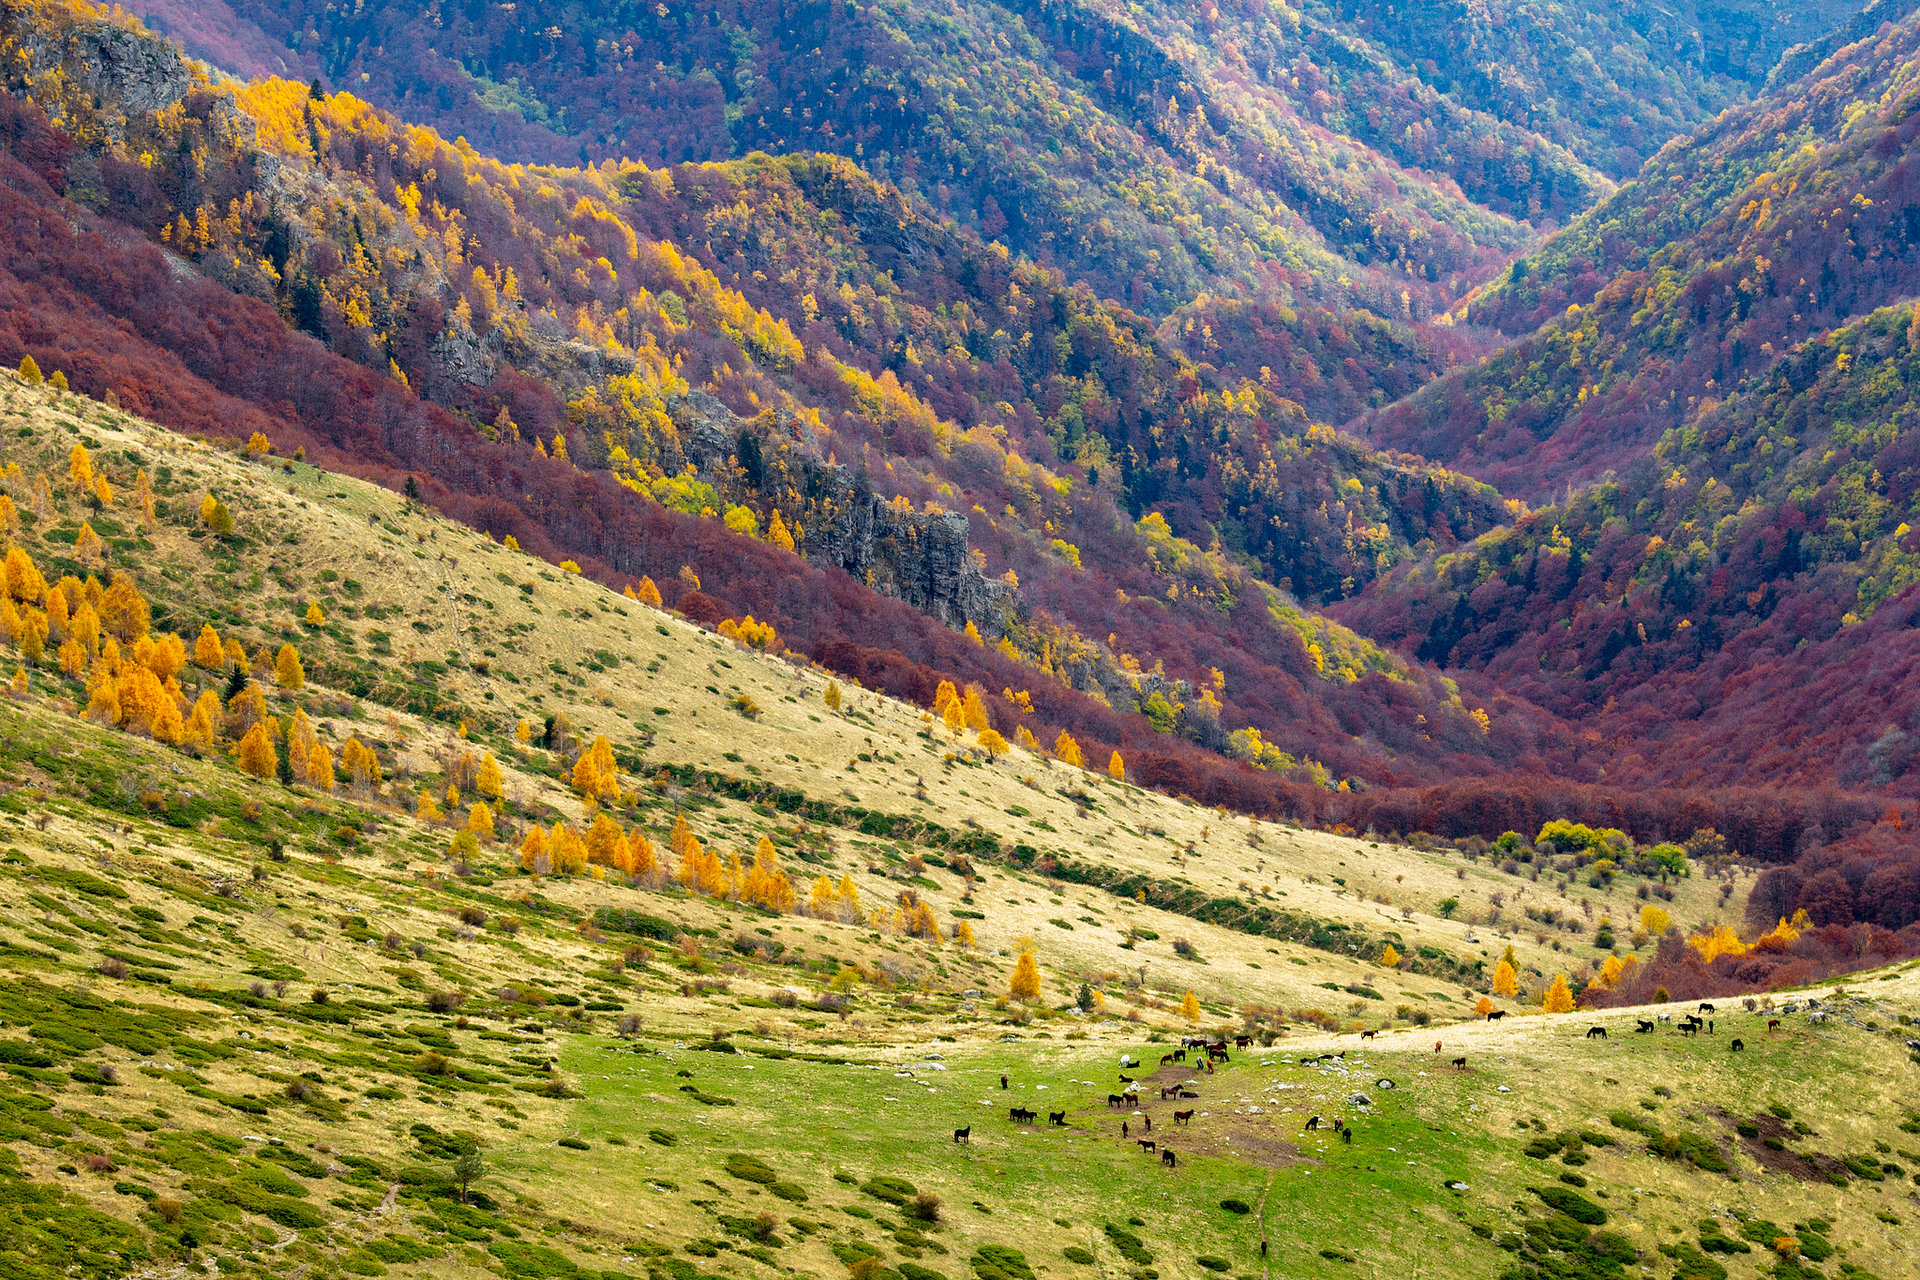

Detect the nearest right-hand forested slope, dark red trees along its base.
xmin=1348 ymin=303 xmax=1920 ymax=794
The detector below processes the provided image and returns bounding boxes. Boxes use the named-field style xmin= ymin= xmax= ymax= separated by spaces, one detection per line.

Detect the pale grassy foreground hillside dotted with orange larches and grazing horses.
xmin=0 ymin=376 xmax=1920 ymax=1280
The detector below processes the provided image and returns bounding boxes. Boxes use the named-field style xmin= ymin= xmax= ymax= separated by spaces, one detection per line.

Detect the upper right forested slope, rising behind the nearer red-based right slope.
xmin=1365 ymin=21 xmax=1920 ymax=501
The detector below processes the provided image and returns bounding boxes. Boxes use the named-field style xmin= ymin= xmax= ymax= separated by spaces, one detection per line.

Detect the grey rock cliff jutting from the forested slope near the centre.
xmin=668 ymin=391 xmax=1014 ymax=635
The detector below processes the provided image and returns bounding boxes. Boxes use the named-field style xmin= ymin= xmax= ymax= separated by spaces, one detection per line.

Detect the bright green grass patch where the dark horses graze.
xmin=552 ymin=1038 xmax=1498 ymax=1276
